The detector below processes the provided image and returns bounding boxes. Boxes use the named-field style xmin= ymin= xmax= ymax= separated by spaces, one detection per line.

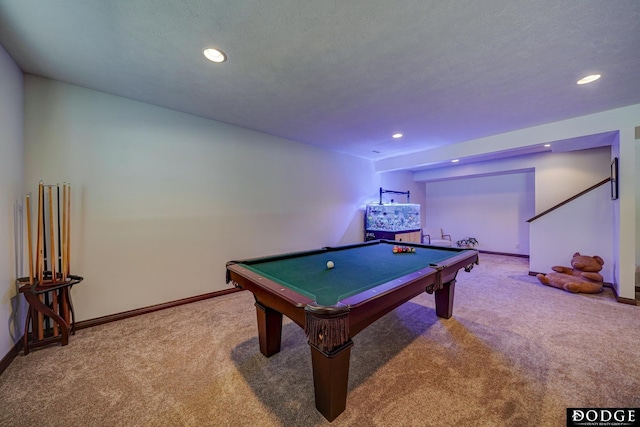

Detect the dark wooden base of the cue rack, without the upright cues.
xmin=17 ymin=272 xmax=84 ymax=355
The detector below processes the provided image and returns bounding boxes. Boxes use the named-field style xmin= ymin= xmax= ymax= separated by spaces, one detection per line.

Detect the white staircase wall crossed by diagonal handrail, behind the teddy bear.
xmin=529 ymin=147 xmax=617 ymax=283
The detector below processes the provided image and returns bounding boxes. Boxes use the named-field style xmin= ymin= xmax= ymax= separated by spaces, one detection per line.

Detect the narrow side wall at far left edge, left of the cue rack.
xmin=0 ymin=46 xmax=25 ymax=359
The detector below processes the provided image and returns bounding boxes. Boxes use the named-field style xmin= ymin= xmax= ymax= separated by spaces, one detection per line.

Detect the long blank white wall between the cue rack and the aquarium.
xmin=25 ymin=76 xmax=380 ymax=320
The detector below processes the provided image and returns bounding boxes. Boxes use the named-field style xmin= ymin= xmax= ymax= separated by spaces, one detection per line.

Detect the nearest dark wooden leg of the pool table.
xmin=309 ymin=340 xmax=353 ymax=421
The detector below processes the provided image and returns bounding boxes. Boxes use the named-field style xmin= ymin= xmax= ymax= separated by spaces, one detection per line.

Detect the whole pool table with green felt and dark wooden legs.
xmin=227 ymin=240 xmax=478 ymax=421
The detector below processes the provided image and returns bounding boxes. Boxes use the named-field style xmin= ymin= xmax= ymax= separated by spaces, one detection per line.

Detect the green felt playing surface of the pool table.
xmin=235 ymin=241 xmax=476 ymax=305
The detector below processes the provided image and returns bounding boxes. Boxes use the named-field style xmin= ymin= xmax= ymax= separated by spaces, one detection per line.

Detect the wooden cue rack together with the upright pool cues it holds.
xmin=17 ymin=181 xmax=83 ymax=355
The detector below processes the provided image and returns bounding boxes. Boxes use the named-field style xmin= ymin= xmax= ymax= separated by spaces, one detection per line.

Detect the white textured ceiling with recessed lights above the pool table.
xmin=0 ymin=0 xmax=640 ymax=160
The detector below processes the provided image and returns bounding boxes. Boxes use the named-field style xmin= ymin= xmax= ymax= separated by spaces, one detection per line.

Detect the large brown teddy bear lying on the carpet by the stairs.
xmin=536 ymin=252 xmax=604 ymax=294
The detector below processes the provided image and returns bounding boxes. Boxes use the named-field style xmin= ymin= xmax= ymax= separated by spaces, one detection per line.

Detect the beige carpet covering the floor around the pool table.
xmin=0 ymin=254 xmax=640 ymax=427
